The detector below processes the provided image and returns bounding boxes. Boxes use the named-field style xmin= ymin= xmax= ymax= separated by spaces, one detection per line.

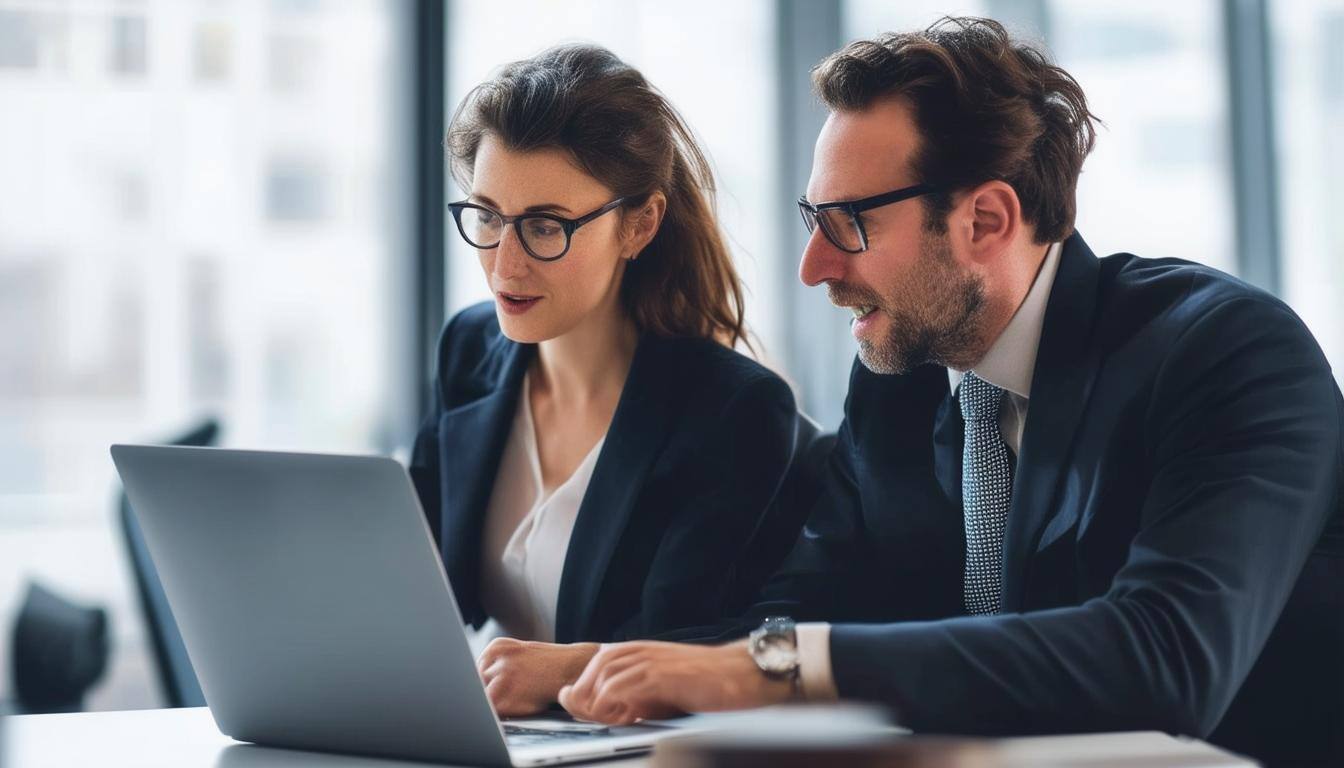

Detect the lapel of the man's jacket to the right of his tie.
xmin=1003 ymin=233 xmax=1101 ymax=612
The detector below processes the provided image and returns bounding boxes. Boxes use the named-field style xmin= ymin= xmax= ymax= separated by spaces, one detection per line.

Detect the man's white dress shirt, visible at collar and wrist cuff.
xmin=797 ymin=242 xmax=1063 ymax=701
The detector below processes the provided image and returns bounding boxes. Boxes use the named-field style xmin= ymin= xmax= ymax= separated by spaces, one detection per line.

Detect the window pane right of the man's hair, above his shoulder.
xmin=1048 ymin=0 xmax=1236 ymax=272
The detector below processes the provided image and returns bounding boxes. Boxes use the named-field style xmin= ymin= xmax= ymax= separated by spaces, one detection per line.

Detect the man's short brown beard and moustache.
xmin=828 ymin=234 xmax=985 ymax=374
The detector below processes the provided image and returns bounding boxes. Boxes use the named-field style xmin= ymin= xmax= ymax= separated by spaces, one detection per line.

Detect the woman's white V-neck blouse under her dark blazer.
xmin=481 ymin=374 xmax=606 ymax=642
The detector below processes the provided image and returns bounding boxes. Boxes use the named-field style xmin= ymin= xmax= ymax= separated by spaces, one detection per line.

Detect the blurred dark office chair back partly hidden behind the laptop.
xmin=118 ymin=418 xmax=219 ymax=707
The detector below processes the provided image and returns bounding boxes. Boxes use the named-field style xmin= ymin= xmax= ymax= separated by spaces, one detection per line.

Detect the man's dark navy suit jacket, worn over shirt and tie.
xmin=753 ymin=234 xmax=1344 ymax=764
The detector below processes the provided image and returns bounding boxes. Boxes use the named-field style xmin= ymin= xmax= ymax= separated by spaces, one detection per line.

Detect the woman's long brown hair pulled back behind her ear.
xmin=446 ymin=44 xmax=746 ymax=347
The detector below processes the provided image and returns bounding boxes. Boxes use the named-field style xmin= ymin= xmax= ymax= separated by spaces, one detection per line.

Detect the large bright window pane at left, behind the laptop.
xmin=0 ymin=0 xmax=411 ymax=707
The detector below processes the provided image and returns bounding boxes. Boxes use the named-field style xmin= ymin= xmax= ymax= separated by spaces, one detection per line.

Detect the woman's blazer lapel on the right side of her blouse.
xmin=555 ymin=336 xmax=677 ymax=643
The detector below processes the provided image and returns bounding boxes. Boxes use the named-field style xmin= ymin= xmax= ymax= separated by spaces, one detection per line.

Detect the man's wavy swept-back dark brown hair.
xmin=812 ymin=16 xmax=1099 ymax=243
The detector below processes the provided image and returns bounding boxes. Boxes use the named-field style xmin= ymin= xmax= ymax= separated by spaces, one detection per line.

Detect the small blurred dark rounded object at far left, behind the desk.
xmin=13 ymin=584 xmax=108 ymax=714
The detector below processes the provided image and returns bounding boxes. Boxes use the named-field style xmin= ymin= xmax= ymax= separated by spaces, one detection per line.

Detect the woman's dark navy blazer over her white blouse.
xmin=410 ymin=303 xmax=798 ymax=643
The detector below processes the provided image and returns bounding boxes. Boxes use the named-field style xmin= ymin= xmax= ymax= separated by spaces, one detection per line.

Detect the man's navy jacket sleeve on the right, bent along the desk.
xmin=831 ymin=297 xmax=1340 ymax=737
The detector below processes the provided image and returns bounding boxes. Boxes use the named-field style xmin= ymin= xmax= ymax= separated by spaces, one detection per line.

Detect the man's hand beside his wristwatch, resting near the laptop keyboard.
xmin=560 ymin=642 xmax=793 ymax=725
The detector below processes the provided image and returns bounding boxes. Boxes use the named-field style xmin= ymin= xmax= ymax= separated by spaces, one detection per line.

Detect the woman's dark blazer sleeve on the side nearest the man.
xmin=613 ymin=375 xmax=798 ymax=640
